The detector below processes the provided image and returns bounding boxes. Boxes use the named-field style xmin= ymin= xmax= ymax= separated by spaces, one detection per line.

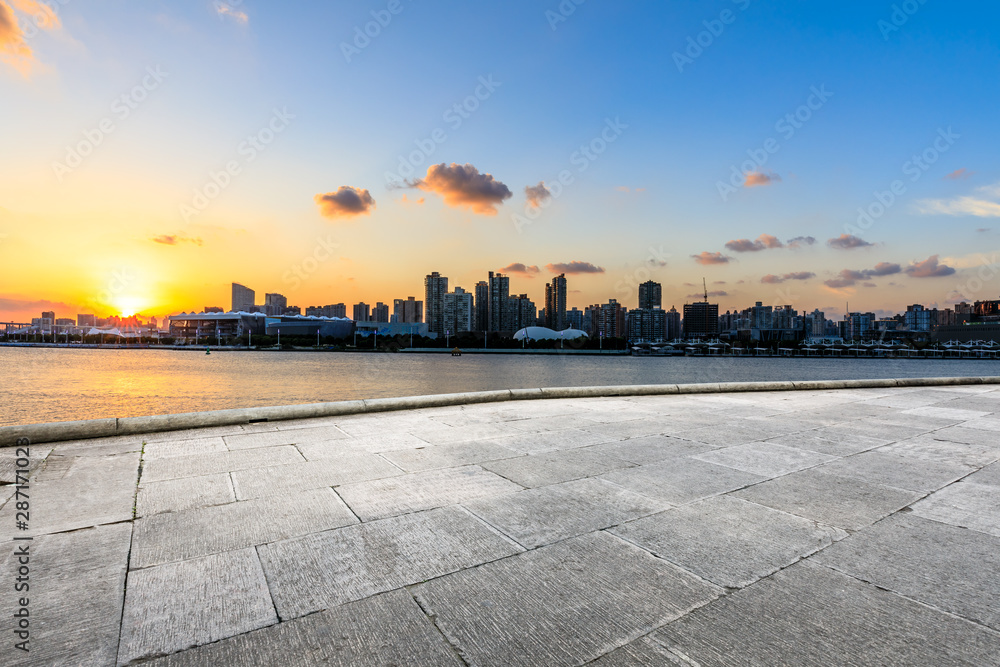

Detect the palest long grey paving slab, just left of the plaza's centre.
xmin=337 ymin=466 xmax=522 ymax=521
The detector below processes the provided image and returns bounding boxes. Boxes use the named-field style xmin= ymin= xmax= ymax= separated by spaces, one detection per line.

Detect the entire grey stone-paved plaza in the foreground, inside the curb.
xmin=0 ymin=385 xmax=1000 ymax=667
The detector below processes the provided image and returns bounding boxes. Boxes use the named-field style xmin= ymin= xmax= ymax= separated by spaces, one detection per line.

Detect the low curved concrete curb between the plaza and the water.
xmin=0 ymin=377 xmax=1000 ymax=447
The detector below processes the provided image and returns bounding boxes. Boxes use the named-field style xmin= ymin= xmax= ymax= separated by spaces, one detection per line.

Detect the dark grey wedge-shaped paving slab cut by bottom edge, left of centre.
xmin=149 ymin=591 xmax=464 ymax=667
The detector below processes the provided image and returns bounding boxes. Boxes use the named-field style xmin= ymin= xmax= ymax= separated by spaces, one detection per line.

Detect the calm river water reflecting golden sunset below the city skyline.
xmin=0 ymin=348 xmax=1000 ymax=424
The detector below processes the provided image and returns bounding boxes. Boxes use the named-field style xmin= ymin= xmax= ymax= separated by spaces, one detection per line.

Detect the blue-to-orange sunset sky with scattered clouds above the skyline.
xmin=0 ymin=0 xmax=1000 ymax=321
